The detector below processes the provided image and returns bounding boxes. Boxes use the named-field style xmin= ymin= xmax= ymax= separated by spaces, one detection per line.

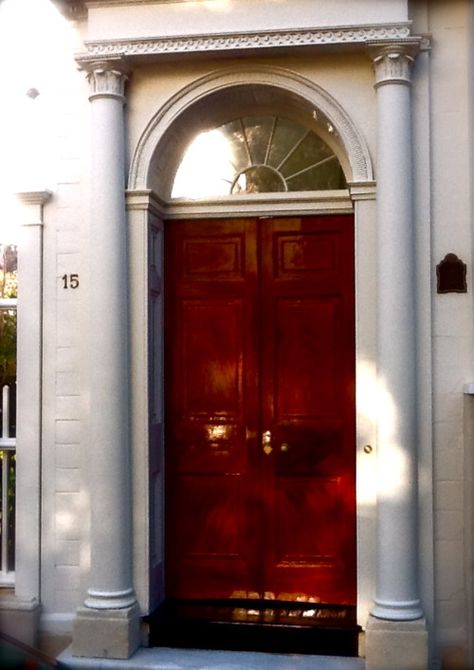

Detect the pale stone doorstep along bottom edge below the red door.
xmin=58 ymin=647 xmax=365 ymax=670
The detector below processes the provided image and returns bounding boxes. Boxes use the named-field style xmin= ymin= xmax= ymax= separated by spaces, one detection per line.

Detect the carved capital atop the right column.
xmin=368 ymin=40 xmax=420 ymax=88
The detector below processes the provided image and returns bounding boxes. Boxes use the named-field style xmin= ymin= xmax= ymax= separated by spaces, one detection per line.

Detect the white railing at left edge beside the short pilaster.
xmin=0 ymin=298 xmax=17 ymax=586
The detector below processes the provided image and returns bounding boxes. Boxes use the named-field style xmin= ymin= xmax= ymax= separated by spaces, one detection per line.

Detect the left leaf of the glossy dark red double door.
xmin=165 ymin=220 xmax=257 ymax=598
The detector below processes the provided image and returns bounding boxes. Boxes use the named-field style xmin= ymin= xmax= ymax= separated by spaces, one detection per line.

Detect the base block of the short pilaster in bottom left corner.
xmin=0 ymin=594 xmax=41 ymax=647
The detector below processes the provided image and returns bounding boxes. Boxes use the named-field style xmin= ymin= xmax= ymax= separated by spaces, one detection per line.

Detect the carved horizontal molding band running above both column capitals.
xmin=79 ymin=22 xmax=410 ymax=61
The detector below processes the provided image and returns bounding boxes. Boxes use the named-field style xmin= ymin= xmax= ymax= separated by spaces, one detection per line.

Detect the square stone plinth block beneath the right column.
xmin=365 ymin=616 xmax=428 ymax=670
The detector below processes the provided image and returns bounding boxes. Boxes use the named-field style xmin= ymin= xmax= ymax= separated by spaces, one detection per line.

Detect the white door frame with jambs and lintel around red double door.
xmin=127 ymin=184 xmax=377 ymax=626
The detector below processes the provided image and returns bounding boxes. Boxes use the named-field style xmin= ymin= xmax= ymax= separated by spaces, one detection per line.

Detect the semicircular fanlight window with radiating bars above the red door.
xmin=171 ymin=116 xmax=346 ymax=198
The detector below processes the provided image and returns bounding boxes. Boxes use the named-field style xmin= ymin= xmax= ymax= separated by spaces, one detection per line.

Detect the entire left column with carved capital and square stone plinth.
xmin=73 ymin=60 xmax=138 ymax=658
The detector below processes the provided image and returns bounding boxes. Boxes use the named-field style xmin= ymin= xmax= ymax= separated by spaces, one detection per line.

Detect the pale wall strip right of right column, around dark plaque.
xmin=428 ymin=0 xmax=473 ymax=660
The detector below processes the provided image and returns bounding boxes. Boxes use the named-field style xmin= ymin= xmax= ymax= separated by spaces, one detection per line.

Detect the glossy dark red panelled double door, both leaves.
xmin=165 ymin=216 xmax=356 ymax=604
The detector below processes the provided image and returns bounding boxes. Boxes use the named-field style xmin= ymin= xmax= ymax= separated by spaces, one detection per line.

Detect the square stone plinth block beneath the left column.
xmin=72 ymin=605 xmax=140 ymax=658
